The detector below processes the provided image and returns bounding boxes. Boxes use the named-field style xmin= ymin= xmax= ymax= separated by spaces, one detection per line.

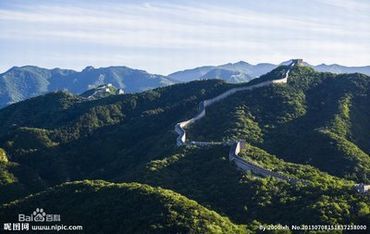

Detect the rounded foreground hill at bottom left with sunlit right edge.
xmin=0 ymin=181 xmax=246 ymax=233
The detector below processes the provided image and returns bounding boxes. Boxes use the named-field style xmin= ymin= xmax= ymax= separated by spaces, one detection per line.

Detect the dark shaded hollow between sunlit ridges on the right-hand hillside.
xmin=260 ymin=80 xmax=362 ymax=177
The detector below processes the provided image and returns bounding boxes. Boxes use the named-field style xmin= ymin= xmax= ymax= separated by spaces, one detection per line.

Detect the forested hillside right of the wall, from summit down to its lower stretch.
xmin=188 ymin=66 xmax=370 ymax=183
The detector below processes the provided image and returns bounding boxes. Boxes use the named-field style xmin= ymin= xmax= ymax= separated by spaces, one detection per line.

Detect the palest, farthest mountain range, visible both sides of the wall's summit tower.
xmin=168 ymin=60 xmax=370 ymax=83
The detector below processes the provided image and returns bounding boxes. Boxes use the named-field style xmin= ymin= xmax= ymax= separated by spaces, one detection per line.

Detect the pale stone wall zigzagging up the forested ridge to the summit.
xmin=175 ymin=60 xmax=299 ymax=183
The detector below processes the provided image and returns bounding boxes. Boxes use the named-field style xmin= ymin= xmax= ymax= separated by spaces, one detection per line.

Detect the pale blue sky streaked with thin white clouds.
xmin=0 ymin=0 xmax=370 ymax=74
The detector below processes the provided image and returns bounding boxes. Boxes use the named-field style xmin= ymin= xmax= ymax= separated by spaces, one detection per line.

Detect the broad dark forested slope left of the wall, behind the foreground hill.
xmin=0 ymin=81 xmax=228 ymax=201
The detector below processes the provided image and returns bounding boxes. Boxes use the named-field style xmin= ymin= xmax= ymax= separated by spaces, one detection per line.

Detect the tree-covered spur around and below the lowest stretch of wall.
xmin=135 ymin=146 xmax=370 ymax=224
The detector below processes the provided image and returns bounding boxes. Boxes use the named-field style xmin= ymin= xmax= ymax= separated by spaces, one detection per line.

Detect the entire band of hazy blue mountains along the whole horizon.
xmin=0 ymin=61 xmax=370 ymax=108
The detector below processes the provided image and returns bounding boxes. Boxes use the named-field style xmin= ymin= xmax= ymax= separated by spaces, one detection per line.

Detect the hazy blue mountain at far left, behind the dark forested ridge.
xmin=0 ymin=66 xmax=174 ymax=107
